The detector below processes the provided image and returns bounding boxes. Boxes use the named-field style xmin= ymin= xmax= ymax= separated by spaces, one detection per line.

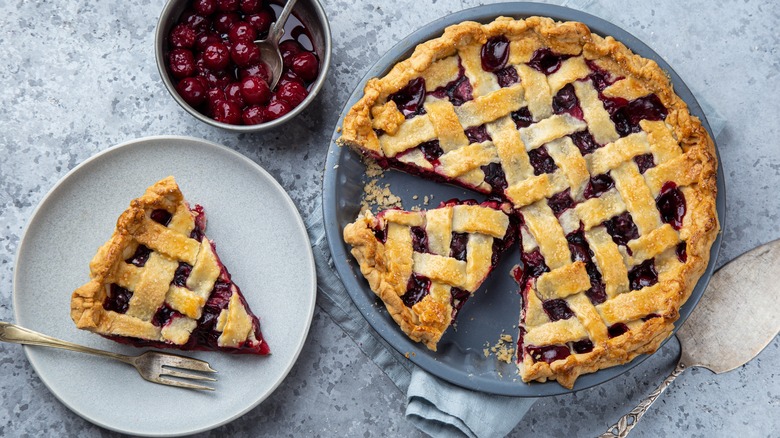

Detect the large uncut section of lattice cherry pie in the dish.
xmin=339 ymin=17 xmax=719 ymax=388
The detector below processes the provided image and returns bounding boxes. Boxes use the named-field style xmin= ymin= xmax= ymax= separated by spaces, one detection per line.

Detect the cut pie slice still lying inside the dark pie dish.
xmin=344 ymin=200 xmax=516 ymax=351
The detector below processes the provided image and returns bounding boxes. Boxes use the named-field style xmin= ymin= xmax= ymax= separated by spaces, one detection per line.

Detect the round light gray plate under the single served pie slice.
xmin=8 ymin=136 xmax=317 ymax=436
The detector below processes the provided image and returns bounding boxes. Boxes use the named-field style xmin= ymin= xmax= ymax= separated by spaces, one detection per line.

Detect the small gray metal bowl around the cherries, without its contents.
xmin=154 ymin=0 xmax=331 ymax=132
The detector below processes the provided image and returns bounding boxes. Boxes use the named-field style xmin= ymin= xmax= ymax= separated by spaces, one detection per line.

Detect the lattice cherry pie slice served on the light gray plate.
xmin=71 ymin=177 xmax=270 ymax=355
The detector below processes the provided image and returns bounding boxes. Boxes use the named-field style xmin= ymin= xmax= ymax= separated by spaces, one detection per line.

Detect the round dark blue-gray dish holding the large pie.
xmin=323 ymin=3 xmax=726 ymax=397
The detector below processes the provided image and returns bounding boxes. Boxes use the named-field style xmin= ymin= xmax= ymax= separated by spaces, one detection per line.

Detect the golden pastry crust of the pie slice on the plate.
xmin=71 ymin=177 xmax=258 ymax=348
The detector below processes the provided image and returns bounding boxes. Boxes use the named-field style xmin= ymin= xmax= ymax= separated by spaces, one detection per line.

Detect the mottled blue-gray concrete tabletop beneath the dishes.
xmin=0 ymin=0 xmax=780 ymax=437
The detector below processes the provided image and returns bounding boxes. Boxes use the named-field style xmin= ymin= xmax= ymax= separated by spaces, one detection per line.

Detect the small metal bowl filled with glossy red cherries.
xmin=155 ymin=0 xmax=331 ymax=132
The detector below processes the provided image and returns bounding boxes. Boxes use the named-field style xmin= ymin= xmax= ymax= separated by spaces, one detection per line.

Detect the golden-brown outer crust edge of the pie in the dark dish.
xmin=338 ymin=17 xmax=719 ymax=388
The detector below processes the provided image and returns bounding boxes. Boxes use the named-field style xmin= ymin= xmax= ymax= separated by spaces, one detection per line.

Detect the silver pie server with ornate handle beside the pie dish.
xmin=601 ymin=240 xmax=780 ymax=438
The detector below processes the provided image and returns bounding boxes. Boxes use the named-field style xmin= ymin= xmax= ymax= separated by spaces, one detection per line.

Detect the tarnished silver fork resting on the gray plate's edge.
xmin=0 ymin=321 xmax=217 ymax=391
